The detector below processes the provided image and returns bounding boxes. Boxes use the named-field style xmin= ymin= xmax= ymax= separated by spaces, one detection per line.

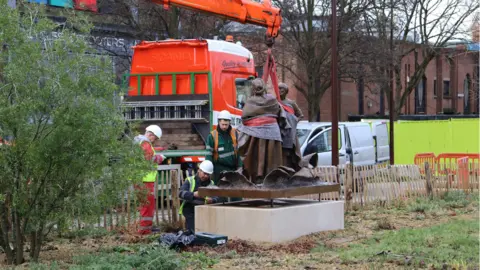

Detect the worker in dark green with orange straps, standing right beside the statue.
xmin=206 ymin=110 xmax=242 ymax=185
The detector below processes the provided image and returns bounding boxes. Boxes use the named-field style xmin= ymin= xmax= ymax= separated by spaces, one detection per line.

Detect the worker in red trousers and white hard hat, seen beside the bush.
xmin=134 ymin=125 xmax=165 ymax=234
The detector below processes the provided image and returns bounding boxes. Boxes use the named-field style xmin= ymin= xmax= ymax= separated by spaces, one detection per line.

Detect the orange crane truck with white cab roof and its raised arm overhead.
xmin=122 ymin=0 xmax=282 ymax=172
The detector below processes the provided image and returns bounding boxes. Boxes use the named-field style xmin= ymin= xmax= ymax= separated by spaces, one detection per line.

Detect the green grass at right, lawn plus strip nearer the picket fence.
xmin=313 ymin=191 xmax=480 ymax=269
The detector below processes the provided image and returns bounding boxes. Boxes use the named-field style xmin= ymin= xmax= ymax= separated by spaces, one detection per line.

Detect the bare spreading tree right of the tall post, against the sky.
xmin=364 ymin=0 xmax=479 ymax=114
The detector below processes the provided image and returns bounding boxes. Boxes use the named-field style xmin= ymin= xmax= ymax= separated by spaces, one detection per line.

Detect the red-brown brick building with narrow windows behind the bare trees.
xmin=236 ymin=26 xmax=479 ymax=121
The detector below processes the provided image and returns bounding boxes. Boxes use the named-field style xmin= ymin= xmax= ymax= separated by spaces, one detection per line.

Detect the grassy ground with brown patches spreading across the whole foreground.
xmin=15 ymin=191 xmax=480 ymax=270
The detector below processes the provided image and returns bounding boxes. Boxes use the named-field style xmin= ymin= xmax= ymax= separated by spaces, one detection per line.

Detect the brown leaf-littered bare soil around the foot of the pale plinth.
xmin=0 ymin=199 xmax=479 ymax=269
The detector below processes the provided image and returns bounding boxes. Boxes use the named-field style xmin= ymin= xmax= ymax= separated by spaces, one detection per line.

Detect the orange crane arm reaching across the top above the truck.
xmin=152 ymin=0 xmax=282 ymax=38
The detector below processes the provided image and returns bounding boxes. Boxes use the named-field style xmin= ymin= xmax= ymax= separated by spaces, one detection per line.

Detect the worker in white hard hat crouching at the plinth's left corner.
xmin=179 ymin=160 xmax=218 ymax=232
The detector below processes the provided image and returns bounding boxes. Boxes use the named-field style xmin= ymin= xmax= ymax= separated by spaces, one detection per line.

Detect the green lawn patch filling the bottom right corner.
xmin=339 ymin=220 xmax=480 ymax=267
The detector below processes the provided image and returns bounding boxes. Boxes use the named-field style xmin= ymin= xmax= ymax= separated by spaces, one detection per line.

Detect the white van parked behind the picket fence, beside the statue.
xmin=297 ymin=121 xmax=390 ymax=166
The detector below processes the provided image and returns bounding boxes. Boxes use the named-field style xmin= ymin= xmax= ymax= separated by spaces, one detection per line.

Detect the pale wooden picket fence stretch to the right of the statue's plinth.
xmin=286 ymin=162 xmax=480 ymax=208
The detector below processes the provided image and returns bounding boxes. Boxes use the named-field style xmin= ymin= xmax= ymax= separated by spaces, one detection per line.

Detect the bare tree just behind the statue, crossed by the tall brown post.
xmin=274 ymin=0 xmax=371 ymax=120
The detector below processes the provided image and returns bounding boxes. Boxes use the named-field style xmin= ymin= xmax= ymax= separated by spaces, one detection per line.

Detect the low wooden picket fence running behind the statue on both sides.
xmin=75 ymin=162 xmax=480 ymax=229
